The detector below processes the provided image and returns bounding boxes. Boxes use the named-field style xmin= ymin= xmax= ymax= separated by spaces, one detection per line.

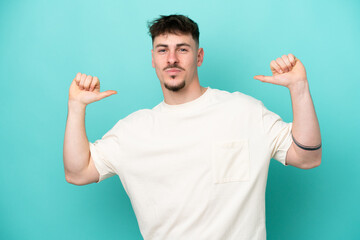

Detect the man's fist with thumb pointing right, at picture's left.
xmin=69 ymin=73 xmax=117 ymax=106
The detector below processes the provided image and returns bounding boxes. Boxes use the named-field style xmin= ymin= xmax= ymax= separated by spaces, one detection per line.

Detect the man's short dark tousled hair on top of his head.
xmin=148 ymin=14 xmax=200 ymax=45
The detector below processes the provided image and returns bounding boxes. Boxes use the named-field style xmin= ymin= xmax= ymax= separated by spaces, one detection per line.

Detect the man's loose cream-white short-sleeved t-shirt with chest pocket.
xmin=89 ymin=88 xmax=292 ymax=240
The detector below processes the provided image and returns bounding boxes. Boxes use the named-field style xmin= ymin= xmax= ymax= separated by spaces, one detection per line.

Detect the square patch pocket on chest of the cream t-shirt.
xmin=211 ymin=139 xmax=250 ymax=183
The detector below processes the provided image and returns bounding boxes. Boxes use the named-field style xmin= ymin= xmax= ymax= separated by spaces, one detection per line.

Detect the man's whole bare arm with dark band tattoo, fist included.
xmin=254 ymin=54 xmax=322 ymax=169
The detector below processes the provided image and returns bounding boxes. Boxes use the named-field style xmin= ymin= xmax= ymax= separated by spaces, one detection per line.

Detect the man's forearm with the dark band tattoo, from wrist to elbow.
xmin=289 ymin=81 xmax=321 ymax=159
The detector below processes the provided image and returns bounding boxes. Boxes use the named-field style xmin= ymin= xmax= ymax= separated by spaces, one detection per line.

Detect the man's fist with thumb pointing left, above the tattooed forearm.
xmin=254 ymin=53 xmax=307 ymax=89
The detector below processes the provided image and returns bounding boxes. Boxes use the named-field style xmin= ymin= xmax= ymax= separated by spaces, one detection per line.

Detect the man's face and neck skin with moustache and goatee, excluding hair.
xmin=151 ymin=34 xmax=206 ymax=104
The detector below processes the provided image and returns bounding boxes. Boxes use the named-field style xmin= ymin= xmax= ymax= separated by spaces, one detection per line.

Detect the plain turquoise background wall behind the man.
xmin=0 ymin=0 xmax=360 ymax=240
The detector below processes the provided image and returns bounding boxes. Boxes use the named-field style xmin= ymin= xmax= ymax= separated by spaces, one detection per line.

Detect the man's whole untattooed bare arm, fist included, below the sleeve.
xmin=63 ymin=73 xmax=116 ymax=185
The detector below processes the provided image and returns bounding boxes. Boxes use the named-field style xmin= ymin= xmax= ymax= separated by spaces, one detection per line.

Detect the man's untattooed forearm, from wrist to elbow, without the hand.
xmin=63 ymin=101 xmax=90 ymax=177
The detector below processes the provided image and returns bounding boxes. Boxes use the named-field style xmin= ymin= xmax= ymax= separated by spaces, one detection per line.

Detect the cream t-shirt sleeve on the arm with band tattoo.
xmin=261 ymin=101 xmax=293 ymax=165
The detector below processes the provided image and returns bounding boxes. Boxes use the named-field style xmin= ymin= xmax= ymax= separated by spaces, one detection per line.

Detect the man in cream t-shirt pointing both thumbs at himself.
xmin=64 ymin=15 xmax=321 ymax=240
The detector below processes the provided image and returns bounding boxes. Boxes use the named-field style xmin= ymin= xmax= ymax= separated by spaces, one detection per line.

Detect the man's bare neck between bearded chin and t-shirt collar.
xmin=161 ymin=81 xmax=206 ymax=105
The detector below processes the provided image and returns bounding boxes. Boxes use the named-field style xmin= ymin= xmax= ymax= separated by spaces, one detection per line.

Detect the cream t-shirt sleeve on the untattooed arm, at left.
xmin=89 ymin=124 xmax=119 ymax=183
